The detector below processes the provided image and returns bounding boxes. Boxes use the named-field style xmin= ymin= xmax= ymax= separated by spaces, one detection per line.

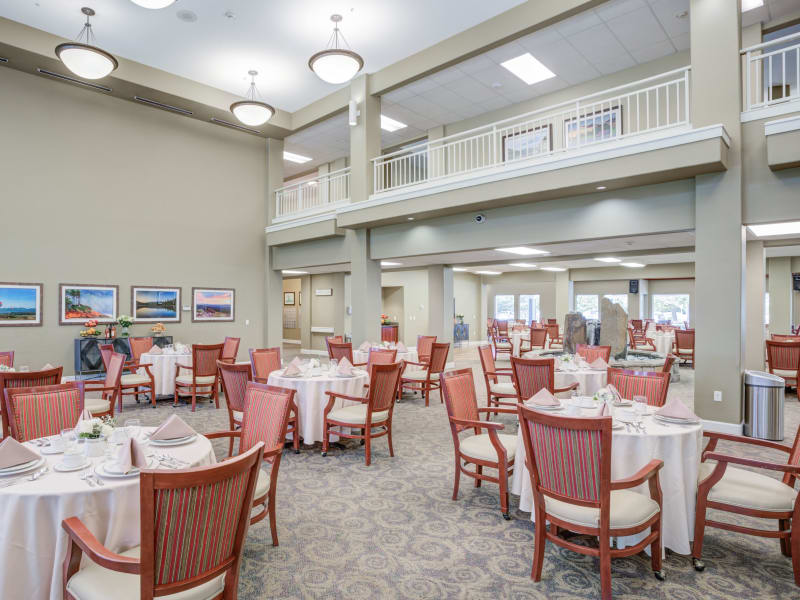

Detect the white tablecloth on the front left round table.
xmin=0 ymin=426 xmax=216 ymax=600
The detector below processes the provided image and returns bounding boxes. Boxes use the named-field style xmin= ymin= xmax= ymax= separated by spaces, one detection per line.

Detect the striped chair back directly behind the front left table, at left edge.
xmin=4 ymin=381 xmax=83 ymax=442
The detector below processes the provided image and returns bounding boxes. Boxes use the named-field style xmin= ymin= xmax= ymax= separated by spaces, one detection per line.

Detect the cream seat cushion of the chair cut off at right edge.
xmin=698 ymin=462 xmax=797 ymax=512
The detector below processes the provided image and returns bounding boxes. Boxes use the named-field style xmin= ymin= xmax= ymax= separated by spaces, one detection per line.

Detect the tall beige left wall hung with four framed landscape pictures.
xmin=0 ymin=69 xmax=267 ymax=373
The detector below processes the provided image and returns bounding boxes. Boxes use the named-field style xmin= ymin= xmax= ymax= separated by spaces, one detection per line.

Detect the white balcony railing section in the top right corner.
xmin=741 ymin=33 xmax=800 ymax=111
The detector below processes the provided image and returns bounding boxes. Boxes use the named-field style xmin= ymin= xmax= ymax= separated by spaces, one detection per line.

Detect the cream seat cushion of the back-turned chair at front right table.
xmin=544 ymin=490 xmax=658 ymax=529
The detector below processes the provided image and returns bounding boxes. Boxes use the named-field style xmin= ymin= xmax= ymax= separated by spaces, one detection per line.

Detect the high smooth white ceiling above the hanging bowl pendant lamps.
xmin=0 ymin=0 xmax=522 ymax=111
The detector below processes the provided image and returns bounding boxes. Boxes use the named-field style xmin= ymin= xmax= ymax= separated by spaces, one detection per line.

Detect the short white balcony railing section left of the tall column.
xmin=275 ymin=167 xmax=350 ymax=217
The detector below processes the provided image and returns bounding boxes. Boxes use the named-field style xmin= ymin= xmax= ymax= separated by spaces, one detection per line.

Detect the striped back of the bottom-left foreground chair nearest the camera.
xmin=139 ymin=444 xmax=263 ymax=598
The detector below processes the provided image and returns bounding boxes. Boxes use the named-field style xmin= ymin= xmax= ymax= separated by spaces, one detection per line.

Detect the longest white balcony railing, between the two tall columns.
xmin=372 ymin=67 xmax=690 ymax=194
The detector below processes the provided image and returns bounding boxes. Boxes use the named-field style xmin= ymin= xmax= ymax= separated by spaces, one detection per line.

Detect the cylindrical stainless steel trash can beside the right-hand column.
xmin=744 ymin=371 xmax=786 ymax=441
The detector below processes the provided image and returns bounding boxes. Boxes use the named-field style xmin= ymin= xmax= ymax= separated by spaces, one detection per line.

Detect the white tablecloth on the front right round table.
xmin=511 ymin=411 xmax=703 ymax=554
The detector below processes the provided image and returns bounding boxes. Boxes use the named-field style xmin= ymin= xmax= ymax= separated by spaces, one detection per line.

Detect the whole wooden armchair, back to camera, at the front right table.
xmin=517 ymin=404 xmax=664 ymax=600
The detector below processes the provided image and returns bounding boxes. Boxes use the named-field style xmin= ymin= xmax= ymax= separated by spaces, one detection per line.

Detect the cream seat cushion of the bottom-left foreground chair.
xmin=67 ymin=546 xmax=225 ymax=600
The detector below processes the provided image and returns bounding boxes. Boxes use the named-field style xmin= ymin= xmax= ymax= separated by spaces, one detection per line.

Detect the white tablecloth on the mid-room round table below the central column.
xmin=268 ymin=370 xmax=369 ymax=445
